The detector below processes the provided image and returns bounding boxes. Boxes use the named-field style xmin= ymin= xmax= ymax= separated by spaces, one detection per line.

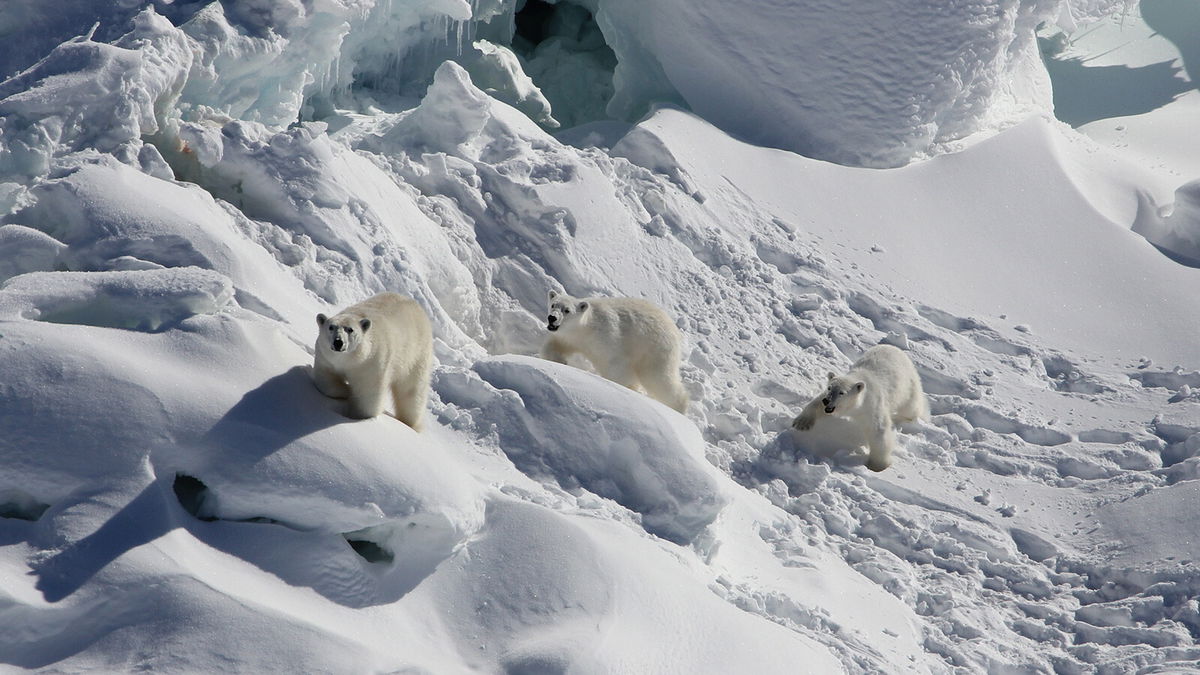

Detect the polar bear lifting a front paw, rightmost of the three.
xmin=792 ymin=345 xmax=929 ymax=471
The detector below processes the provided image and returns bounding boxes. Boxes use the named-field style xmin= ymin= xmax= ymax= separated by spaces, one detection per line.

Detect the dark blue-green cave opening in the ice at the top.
xmin=512 ymin=0 xmax=617 ymax=129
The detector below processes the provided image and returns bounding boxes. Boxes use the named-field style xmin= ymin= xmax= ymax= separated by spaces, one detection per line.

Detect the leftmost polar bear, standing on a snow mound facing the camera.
xmin=312 ymin=293 xmax=433 ymax=431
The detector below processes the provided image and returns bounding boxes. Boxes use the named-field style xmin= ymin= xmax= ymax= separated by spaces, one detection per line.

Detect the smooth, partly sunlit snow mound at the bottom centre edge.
xmin=431 ymin=500 xmax=841 ymax=674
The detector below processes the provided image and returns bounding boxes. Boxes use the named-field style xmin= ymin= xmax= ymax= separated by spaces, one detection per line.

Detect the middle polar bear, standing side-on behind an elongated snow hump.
xmin=541 ymin=291 xmax=688 ymax=412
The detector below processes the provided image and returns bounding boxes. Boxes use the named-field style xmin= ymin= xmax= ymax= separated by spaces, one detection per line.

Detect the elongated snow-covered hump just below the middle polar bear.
xmin=436 ymin=357 xmax=727 ymax=543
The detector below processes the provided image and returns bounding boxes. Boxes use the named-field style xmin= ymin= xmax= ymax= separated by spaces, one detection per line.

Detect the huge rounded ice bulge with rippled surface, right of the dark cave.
xmin=600 ymin=0 xmax=1122 ymax=167
